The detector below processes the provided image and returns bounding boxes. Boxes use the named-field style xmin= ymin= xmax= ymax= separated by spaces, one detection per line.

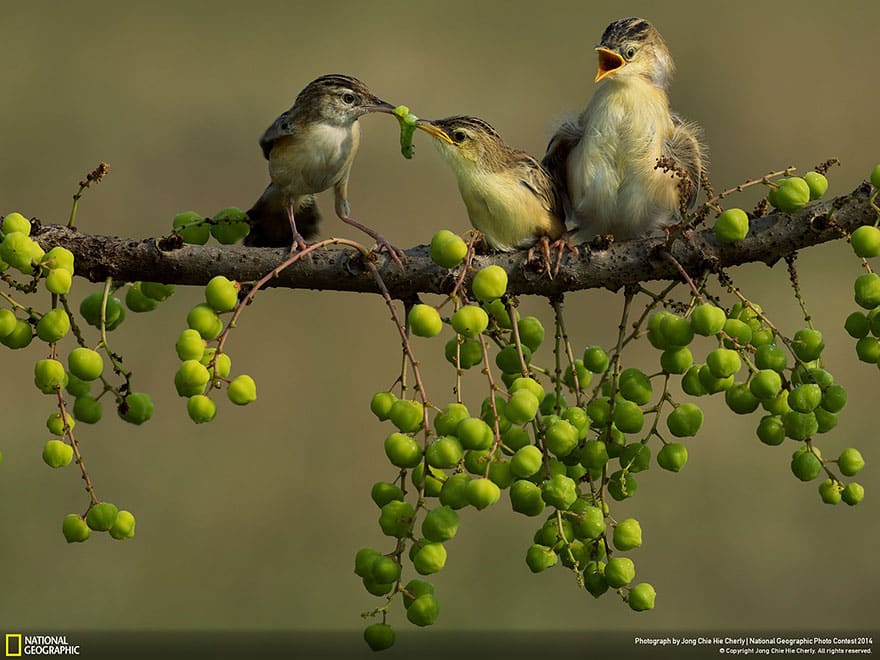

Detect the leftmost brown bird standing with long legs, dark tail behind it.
xmin=244 ymin=74 xmax=402 ymax=264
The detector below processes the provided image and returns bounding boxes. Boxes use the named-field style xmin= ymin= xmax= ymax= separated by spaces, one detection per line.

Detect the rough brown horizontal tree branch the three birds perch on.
xmin=33 ymin=183 xmax=877 ymax=299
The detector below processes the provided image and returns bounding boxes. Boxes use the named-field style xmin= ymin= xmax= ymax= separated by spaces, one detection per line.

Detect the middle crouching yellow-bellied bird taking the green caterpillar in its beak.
xmin=416 ymin=115 xmax=565 ymax=252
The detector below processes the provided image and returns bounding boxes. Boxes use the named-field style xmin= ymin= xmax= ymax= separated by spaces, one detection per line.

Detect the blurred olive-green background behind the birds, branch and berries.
xmin=0 ymin=0 xmax=880 ymax=631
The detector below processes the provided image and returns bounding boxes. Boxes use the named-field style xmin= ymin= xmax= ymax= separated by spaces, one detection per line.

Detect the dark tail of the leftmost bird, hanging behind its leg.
xmin=244 ymin=183 xmax=321 ymax=247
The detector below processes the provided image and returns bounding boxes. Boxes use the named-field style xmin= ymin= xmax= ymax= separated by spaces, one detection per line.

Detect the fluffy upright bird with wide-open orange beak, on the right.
xmin=542 ymin=18 xmax=707 ymax=241
